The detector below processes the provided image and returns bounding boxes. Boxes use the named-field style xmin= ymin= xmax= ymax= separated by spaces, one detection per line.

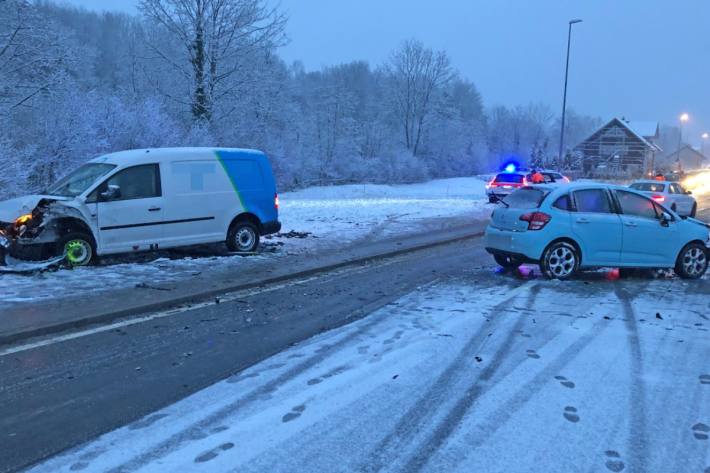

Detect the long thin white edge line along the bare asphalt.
xmin=0 ymin=257 xmax=403 ymax=357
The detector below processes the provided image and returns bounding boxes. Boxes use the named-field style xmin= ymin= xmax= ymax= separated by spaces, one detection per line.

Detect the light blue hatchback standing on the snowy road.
xmin=485 ymin=183 xmax=710 ymax=279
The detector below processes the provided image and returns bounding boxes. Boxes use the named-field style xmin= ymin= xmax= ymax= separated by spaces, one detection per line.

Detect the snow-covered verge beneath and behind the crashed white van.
xmin=0 ymin=177 xmax=491 ymax=303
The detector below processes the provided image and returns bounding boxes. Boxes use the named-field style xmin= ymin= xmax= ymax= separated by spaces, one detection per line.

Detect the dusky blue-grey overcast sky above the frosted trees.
xmin=65 ymin=0 xmax=710 ymax=146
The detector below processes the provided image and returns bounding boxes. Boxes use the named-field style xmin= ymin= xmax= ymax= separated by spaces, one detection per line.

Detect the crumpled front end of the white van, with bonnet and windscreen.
xmin=0 ymin=162 xmax=116 ymax=267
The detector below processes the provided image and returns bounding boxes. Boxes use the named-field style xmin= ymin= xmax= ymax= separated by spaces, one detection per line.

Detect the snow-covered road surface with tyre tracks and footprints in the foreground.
xmin=32 ymin=271 xmax=710 ymax=473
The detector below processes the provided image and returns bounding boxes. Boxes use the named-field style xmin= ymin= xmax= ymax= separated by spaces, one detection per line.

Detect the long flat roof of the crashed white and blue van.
xmin=89 ymin=148 xmax=264 ymax=166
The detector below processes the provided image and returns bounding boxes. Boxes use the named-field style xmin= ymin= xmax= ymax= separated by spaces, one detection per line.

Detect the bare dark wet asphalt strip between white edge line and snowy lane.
xmin=0 ymin=234 xmax=490 ymax=471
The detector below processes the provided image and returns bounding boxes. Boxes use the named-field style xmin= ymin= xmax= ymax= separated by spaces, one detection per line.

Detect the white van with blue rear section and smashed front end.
xmin=0 ymin=148 xmax=281 ymax=266
